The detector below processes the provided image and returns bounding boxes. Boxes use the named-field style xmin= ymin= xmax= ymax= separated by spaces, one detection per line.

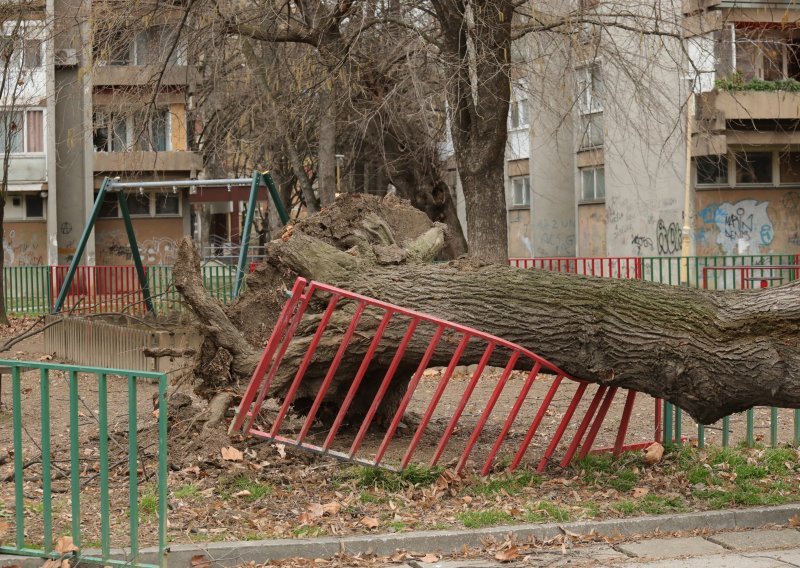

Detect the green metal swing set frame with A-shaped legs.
xmin=52 ymin=170 xmax=289 ymax=315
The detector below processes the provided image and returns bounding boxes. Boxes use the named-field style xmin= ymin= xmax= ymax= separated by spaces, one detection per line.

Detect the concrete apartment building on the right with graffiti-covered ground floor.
xmin=490 ymin=0 xmax=800 ymax=257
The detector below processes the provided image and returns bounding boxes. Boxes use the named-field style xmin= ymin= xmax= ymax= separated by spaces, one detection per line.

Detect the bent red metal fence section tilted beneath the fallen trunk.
xmin=230 ymin=278 xmax=660 ymax=475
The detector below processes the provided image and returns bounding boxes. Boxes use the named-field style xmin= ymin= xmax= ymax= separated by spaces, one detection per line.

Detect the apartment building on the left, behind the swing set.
xmin=0 ymin=0 xmax=202 ymax=265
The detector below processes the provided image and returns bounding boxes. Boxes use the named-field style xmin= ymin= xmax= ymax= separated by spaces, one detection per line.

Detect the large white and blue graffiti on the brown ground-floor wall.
xmin=699 ymin=199 xmax=775 ymax=254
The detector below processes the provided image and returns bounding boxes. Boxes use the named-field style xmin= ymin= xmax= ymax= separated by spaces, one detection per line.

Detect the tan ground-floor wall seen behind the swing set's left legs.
xmin=95 ymin=217 xmax=187 ymax=266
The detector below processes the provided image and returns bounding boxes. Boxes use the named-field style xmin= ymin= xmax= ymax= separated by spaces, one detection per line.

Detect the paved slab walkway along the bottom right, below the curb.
xmin=410 ymin=528 xmax=800 ymax=568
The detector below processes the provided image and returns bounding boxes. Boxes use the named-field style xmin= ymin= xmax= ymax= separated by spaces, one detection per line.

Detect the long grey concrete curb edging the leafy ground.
xmin=0 ymin=504 xmax=800 ymax=568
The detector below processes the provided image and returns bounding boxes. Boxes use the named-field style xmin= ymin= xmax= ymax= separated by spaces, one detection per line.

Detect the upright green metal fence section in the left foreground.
xmin=0 ymin=360 xmax=167 ymax=567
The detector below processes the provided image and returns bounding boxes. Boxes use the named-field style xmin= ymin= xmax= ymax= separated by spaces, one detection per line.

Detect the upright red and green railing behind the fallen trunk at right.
xmin=509 ymin=254 xmax=800 ymax=448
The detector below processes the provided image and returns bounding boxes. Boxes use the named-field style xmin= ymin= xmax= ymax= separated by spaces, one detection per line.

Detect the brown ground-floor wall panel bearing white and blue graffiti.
xmin=695 ymin=189 xmax=800 ymax=255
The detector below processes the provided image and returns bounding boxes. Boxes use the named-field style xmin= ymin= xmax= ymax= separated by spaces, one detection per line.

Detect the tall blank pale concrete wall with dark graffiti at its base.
xmin=600 ymin=1 xmax=687 ymax=256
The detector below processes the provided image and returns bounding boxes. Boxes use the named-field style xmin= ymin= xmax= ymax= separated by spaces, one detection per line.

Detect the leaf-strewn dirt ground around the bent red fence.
xmin=0 ymin=320 xmax=793 ymax=547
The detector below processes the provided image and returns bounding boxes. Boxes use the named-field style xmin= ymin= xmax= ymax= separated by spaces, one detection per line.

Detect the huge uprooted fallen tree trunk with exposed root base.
xmin=175 ymin=195 xmax=800 ymax=424
